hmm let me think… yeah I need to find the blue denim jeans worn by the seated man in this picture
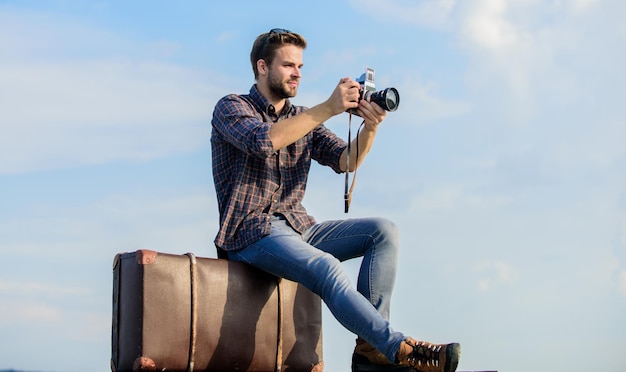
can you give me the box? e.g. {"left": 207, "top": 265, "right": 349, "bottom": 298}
{"left": 228, "top": 216, "right": 405, "bottom": 362}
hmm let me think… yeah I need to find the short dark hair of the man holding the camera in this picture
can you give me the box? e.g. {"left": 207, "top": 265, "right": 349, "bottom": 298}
{"left": 250, "top": 28, "right": 306, "bottom": 79}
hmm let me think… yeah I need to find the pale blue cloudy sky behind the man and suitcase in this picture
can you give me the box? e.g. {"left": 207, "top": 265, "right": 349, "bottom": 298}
{"left": 0, "top": 0, "right": 626, "bottom": 372}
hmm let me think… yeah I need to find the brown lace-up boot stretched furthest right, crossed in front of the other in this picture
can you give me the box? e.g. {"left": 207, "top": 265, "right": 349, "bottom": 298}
{"left": 396, "top": 338, "right": 461, "bottom": 372}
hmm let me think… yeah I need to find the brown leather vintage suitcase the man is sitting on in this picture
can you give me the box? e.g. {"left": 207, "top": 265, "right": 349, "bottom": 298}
{"left": 111, "top": 250, "right": 323, "bottom": 372}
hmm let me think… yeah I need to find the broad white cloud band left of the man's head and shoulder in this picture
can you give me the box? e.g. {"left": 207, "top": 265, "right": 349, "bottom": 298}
{"left": 0, "top": 61, "right": 210, "bottom": 173}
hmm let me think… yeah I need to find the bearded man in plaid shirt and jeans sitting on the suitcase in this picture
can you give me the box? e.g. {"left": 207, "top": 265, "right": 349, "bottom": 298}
{"left": 211, "top": 29, "right": 460, "bottom": 372}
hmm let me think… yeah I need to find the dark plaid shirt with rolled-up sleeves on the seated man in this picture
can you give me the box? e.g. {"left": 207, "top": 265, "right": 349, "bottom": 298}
{"left": 211, "top": 85, "right": 347, "bottom": 250}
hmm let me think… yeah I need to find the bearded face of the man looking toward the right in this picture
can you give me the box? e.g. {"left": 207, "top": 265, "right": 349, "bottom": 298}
{"left": 267, "top": 45, "right": 302, "bottom": 99}
